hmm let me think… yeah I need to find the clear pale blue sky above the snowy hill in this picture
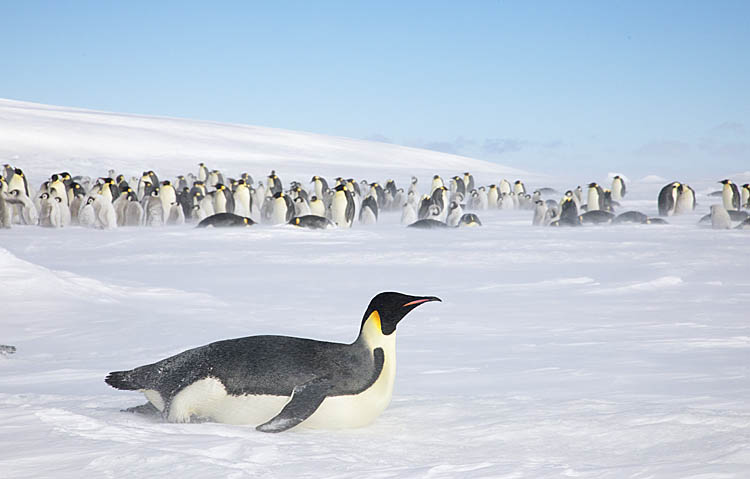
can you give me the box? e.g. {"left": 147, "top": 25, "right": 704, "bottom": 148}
{"left": 0, "top": 1, "right": 750, "bottom": 174}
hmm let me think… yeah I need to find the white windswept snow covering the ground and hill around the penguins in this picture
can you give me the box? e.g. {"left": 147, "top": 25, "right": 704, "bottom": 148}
{"left": 0, "top": 101, "right": 750, "bottom": 479}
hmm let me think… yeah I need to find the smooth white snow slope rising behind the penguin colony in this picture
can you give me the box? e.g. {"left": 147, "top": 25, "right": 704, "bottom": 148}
{"left": 0, "top": 99, "right": 522, "bottom": 181}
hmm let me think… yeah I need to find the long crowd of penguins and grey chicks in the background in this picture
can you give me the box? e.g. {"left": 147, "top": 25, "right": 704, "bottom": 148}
{"left": 0, "top": 163, "right": 750, "bottom": 229}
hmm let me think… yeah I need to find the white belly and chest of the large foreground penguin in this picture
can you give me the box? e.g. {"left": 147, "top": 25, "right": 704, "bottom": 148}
{"left": 155, "top": 356, "right": 396, "bottom": 429}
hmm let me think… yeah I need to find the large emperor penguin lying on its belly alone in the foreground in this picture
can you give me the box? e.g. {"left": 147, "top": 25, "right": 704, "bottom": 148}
{"left": 105, "top": 292, "right": 440, "bottom": 432}
